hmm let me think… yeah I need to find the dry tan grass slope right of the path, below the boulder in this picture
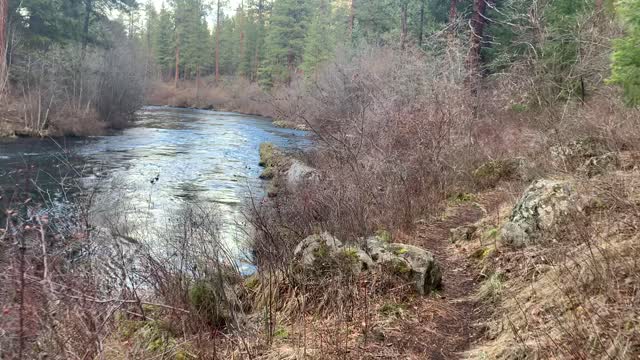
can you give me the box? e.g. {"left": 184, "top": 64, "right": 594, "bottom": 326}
{"left": 467, "top": 172, "right": 640, "bottom": 359}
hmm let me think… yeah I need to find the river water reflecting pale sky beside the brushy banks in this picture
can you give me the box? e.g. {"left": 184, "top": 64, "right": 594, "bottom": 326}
{"left": 0, "top": 107, "right": 308, "bottom": 266}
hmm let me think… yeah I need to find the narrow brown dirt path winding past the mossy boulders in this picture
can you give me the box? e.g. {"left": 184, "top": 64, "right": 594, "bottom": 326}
{"left": 372, "top": 204, "right": 484, "bottom": 360}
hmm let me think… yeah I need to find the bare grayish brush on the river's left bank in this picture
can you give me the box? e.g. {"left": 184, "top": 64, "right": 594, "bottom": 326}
{"left": 0, "top": 40, "right": 144, "bottom": 136}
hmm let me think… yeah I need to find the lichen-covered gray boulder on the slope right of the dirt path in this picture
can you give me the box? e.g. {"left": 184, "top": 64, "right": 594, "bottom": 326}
{"left": 501, "top": 180, "right": 580, "bottom": 247}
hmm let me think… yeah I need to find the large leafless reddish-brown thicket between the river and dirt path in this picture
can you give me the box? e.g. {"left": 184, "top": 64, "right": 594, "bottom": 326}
{"left": 250, "top": 48, "right": 473, "bottom": 261}
